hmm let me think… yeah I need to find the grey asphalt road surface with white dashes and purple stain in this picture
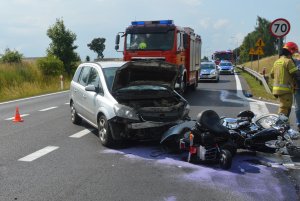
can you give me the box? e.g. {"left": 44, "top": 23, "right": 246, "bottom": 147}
{"left": 0, "top": 75, "right": 299, "bottom": 201}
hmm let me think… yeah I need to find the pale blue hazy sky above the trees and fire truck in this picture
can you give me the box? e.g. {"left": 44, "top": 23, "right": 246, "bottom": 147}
{"left": 0, "top": 0, "right": 300, "bottom": 60}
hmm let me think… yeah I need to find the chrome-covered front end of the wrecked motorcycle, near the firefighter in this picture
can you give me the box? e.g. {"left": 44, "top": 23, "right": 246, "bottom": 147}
{"left": 221, "top": 110, "right": 300, "bottom": 157}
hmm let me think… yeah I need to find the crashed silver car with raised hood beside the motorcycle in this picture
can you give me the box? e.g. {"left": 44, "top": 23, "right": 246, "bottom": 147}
{"left": 70, "top": 61, "right": 190, "bottom": 147}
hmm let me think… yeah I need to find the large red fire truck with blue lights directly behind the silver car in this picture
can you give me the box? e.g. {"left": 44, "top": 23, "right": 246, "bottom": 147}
{"left": 115, "top": 20, "right": 202, "bottom": 93}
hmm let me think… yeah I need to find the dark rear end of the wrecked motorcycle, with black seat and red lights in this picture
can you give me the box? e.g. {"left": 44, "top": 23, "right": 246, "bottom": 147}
{"left": 161, "top": 110, "right": 236, "bottom": 169}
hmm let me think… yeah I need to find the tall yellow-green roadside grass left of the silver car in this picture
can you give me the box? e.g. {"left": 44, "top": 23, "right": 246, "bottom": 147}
{"left": 0, "top": 62, "right": 70, "bottom": 102}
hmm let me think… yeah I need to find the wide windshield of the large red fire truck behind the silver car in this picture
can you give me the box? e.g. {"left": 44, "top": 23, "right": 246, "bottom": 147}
{"left": 126, "top": 31, "right": 174, "bottom": 50}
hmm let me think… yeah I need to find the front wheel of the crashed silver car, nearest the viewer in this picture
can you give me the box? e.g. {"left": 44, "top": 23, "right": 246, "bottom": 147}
{"left": 98, "top": 115, "right": 115, "bottom": 147}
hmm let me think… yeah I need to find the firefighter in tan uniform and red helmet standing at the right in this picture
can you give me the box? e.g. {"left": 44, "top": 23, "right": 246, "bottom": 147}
{"left": 270, "top": 42, "right": 298, "bottom": 117}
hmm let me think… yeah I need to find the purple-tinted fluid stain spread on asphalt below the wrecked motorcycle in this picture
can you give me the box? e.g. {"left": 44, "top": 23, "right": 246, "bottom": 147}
{"left": 101, "top": 146, "right": 298, "bottom": 200}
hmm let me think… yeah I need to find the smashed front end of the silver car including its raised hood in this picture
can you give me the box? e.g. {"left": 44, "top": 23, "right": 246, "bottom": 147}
{"left": 111, "top": 61, "right": 189, "bottom": 140}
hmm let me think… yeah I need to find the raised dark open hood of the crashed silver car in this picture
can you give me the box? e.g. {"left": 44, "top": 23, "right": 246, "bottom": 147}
{"left": 112, "top": 61, "right": 179, "bottom": 91}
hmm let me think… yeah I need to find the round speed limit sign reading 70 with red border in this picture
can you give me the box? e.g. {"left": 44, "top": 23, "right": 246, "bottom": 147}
{"left": 270, "top": 18, "right": 291, "bottom": 38}
